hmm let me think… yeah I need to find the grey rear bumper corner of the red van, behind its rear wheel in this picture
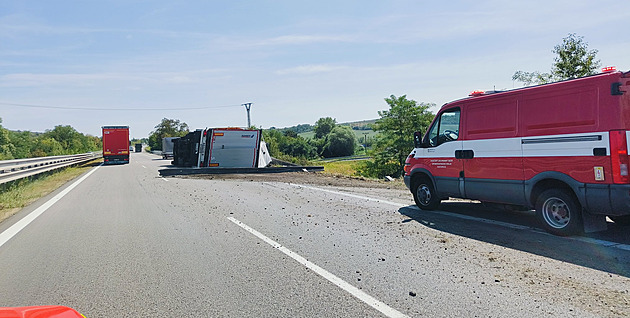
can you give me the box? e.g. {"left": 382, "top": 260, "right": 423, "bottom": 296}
{"left": 585, "top": 184, "right": 630, "bottom": 216}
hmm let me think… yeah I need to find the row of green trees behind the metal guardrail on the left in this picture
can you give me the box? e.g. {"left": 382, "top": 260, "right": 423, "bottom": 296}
{"left": 0, "top": 118, "right": 103, "bottom": 160}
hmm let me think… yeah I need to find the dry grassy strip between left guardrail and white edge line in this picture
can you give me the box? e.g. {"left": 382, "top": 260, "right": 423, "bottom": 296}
{"left": 0, "top": 159, "right": 101, "bottom": 222}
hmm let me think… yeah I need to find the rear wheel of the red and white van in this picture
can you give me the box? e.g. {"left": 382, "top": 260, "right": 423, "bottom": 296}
{"left": 536, "top": 189, "right": 584, "bottom": 236}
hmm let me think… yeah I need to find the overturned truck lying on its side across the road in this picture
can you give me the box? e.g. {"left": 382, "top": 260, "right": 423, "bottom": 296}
{"left": 172, "top": 128, "right": 271, "bottom": 168}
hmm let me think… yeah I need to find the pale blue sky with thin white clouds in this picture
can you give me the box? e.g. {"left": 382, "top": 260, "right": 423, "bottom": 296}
{"left": 0, "top": 0, "right": 630, "bottom": 138}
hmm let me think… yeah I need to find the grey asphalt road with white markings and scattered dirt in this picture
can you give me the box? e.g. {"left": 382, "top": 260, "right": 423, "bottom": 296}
{"left": 0, "top": 153, "right": 630, "bottom": 317}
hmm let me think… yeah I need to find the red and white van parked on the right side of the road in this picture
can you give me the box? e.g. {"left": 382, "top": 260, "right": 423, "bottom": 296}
{"left": 404, "top": 70, "right": 630, "bottom": 235}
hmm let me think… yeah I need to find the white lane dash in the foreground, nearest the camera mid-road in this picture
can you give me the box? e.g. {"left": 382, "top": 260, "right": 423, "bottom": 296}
{"left": 228, "top": 217, "right": 409, "bottom": 317}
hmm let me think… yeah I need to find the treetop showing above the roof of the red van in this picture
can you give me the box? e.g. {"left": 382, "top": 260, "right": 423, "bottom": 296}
{"left": 512, "top": 33, "right": 600, "bottom": 85}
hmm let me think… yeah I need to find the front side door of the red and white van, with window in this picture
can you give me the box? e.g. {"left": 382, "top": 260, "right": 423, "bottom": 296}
{"left": 421, "top": 107, "right": 463, "bottom": 197}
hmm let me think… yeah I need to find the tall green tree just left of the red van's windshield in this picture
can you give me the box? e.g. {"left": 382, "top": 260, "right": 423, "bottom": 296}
{"left": 360, "top": 95, "right": 435, "bottom": 178}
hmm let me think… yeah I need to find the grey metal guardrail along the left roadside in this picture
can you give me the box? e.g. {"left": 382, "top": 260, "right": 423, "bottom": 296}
{"left": 0, "top": 152, "right": 102, "bottom": 184}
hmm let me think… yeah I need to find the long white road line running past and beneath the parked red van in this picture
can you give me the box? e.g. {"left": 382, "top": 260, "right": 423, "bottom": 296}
{"left": 278, "top": 183, "right": 630, "bottom": 251}
